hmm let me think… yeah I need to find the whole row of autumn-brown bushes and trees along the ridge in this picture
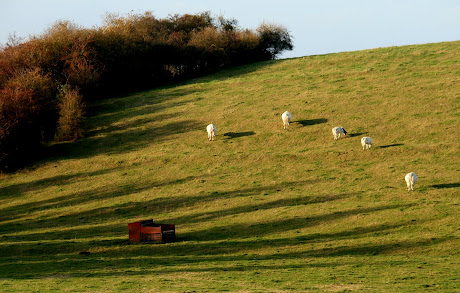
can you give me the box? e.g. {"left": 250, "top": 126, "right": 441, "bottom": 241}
{"left": 0, "top": 12, "right": 292, "bottom": 170}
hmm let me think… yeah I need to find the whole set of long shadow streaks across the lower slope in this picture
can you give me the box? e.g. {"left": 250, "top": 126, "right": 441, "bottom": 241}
{"left": 0, "top": 169, "right": 445, "bottom": 279}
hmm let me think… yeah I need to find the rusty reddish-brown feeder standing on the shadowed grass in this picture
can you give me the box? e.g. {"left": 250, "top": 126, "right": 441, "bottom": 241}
{"left": 128, "top": 220, "right": 176, "bottom": 242}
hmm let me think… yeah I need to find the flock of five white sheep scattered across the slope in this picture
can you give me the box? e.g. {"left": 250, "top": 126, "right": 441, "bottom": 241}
{"left": 206, "top": 111, "right": 418, "bottom": 191}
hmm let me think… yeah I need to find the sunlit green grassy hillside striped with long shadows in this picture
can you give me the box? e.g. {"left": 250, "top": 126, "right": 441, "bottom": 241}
{"left": 0, "top": 42, "right": 460, "bottom": 292}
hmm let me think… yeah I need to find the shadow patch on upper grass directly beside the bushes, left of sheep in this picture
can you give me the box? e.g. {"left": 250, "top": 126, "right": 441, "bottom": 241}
{"left": 34, "top": 88, "right": 201, "bottom": 164}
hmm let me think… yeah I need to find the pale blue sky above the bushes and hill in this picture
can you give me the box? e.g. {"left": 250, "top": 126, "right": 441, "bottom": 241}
{"left": 0, "top": 0, "right": 460, "bottom": 58}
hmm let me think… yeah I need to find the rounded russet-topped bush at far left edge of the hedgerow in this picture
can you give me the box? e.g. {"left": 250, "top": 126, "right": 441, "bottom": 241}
{"left": 0, "top": 68, "right": 57, "bottom": 167}
